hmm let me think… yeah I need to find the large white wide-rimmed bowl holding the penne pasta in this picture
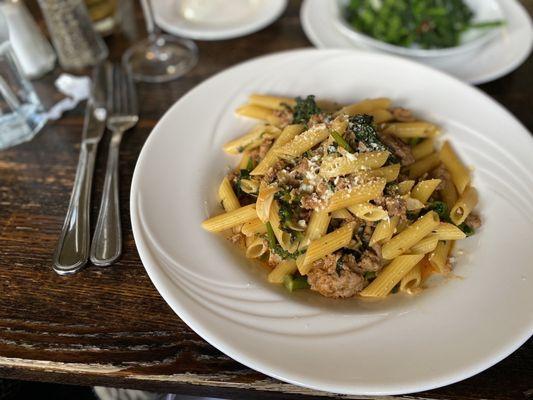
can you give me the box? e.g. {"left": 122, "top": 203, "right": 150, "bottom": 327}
{"left": 131, "top": 49, "right": 533, "bottom": 395}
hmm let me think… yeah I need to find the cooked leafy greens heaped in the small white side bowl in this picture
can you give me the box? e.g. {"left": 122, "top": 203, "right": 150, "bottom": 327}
{"left": 345, "top": 0, "right": 494, "bottom": 49}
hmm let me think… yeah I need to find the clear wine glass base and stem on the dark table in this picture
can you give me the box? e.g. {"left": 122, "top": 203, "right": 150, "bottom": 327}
{"left": 122, "top": 0, "right": 198, "bottom": 82}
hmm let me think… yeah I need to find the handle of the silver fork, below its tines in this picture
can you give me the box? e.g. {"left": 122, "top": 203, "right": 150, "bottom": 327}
{"left": 91, "top": 130, "right": 123, "bottom": 266}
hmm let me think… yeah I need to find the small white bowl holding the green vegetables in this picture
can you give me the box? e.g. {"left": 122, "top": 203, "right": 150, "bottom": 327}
{"left": 331, "top": 0, "right": 505, "bottom": 58}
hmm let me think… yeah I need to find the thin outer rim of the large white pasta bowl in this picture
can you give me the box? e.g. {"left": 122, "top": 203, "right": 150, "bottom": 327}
{"left": 130, "top": 48, "right": 533, "bottom": 396}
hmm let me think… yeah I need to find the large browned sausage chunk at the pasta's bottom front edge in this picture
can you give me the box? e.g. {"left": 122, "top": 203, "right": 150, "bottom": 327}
{"left": 307, "top": 254, "right": 365, "bottom": 298}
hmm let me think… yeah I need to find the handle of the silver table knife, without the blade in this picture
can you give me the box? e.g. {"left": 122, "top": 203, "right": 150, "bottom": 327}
{"left": 53, "top": 142, "right": 97, "bottom": 275}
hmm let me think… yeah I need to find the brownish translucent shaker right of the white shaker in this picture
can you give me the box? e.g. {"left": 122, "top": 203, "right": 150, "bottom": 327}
{"left": 39, "top": 0, "right": 108, "bottom": 70}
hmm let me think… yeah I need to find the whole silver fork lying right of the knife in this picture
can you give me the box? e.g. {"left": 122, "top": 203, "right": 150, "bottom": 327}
{"left": 90, "top": 65, "right": 139, "bottom": 266}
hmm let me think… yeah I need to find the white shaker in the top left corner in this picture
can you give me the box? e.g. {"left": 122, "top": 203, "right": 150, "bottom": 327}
{"left": 0, "top": 0, "right": 56, "bottom": 78}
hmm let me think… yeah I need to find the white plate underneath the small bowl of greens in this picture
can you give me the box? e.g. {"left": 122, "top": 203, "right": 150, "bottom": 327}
{"left": 300, "top": 0, "right": 533, "bottom": 85}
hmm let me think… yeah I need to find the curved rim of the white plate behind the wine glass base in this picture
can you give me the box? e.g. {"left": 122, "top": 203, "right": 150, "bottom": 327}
{"left": 154, "top": 0, "right": 288, "bottom": 41}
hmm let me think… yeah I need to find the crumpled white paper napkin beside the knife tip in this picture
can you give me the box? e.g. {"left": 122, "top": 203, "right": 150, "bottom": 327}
{"left": 45, "top": 74, "right": 91, "bottom": 120}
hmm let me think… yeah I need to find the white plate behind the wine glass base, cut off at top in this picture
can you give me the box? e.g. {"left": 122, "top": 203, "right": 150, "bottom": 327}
{"left": 152, "top": 0, "right": 287, "bottom": 40}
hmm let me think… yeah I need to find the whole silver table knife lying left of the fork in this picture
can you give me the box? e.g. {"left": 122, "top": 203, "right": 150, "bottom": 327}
{"left": 53, "top": 63, "right": 110, "bottom": 275}
